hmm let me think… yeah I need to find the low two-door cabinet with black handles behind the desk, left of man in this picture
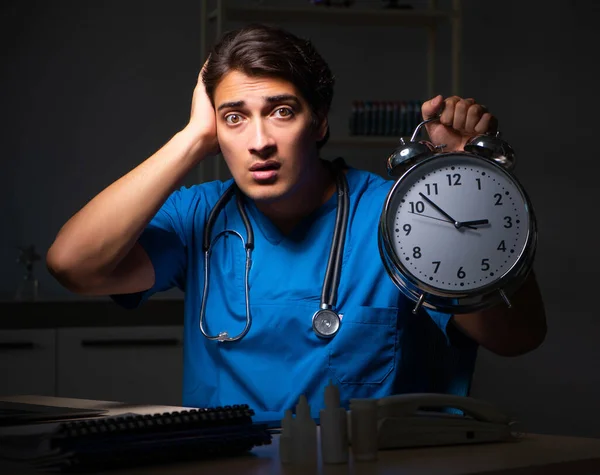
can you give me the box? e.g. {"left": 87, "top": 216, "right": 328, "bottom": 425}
{"left": 0, "top": 325, "right": 183, "bottom": 406}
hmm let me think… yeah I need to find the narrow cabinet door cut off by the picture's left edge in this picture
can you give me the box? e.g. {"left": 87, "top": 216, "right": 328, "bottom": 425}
{"left": 0, "top": 329, "right": 56, "bottom": 396}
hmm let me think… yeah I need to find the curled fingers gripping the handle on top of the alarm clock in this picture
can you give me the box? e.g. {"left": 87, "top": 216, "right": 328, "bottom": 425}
{"left": 440, "top": 96, "right": 498, "bottom": 135}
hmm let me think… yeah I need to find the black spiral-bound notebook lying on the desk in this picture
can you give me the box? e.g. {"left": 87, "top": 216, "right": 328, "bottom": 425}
{"left": 0, "top": 404, "right": 272, "bottom": 472}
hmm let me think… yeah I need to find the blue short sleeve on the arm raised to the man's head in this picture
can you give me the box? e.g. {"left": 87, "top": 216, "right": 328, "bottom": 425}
{"left": 111, "top": 190, "right": 191, "bottom": 308}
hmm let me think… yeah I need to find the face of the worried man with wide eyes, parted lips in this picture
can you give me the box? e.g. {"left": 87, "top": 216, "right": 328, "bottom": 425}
{"left": 214, "top": 71, "right": 326, "bottom": 203}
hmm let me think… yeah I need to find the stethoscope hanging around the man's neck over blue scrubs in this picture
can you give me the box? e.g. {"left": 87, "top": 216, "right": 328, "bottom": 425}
{"left": 199, "top": 162, "right": 349, "bottom": 342}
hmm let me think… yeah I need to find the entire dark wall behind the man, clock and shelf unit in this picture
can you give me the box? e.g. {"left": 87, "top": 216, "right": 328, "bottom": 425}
{"left": 0, "top": 0, "right": 600, "bottom": 437}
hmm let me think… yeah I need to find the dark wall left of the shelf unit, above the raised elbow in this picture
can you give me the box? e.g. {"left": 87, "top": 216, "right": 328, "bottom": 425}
{"left": 0, "top": 0, "right": 201, "bottom": 298}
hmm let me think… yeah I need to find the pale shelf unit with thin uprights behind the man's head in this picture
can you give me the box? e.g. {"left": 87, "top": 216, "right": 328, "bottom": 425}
{"left": 200, "top": 0, "right": 462, "bottom": 177}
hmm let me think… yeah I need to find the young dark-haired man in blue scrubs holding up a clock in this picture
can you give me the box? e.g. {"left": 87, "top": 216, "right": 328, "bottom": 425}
{"left": 47, "top": 26, "right": 546, "bottom": 419}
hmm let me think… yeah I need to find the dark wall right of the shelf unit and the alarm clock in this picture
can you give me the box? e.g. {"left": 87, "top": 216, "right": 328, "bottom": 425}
{"left": 463, "top": 0, "right": 600, "bottom": 437}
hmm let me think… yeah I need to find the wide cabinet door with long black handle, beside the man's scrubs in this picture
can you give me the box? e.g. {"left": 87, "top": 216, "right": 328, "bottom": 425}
{"left": 57, "top": 326, "right": 183, "bottom": 406}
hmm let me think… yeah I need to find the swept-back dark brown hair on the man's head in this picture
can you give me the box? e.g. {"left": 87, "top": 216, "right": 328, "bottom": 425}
{"left": 202, "top": 24, "right": 335, "bottom": 148}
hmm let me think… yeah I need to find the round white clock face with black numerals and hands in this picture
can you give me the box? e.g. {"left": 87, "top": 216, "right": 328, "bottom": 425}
{"left": 387, "top": 154, "right": 530, "bottom": 293}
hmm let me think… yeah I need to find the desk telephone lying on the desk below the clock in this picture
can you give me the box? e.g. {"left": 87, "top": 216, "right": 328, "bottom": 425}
{"left": 377, "top": 393, "right": 522, "bottom": 449}
